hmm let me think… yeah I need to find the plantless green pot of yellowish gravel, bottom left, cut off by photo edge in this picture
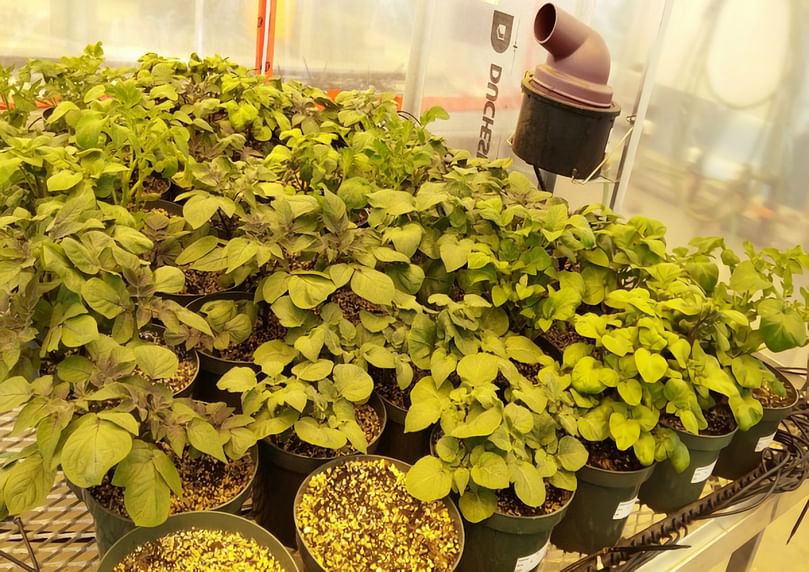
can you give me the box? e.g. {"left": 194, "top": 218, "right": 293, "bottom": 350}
{"left": 98, "top": 511, "right": 298, "bottom": 572}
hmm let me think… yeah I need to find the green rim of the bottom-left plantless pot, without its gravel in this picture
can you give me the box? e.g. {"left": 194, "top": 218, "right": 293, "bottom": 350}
{"left": 98, "top": 511, "right": 298, "bottom": 572}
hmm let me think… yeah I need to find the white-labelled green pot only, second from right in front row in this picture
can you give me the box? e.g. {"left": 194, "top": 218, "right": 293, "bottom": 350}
{"left": 639, "top": 429, "right": 736, "bottom": 512}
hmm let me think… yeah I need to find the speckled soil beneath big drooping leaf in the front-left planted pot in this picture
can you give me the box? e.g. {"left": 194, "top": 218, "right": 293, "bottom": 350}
{"left": 90, "top": 443, "right": 255, "bottom": 518}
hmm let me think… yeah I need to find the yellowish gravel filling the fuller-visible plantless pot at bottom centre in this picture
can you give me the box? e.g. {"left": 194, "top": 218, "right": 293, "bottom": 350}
{"left": 296, "top": 459, "right": 461, "bottom": 572}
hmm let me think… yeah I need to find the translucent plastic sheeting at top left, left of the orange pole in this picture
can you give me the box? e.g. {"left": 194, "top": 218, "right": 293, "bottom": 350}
{"left": 0, "top": 0, "right": 257, "bottom": 67}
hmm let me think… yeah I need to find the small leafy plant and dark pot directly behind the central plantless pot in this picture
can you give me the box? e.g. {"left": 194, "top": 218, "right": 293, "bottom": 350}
{"left": 218, "top": 358, "right": 386, "bottom": 544}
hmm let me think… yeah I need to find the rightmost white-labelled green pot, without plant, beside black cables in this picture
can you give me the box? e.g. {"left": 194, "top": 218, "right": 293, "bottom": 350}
{"left": 714, "top": 364, "right": 798, "bottom": 479}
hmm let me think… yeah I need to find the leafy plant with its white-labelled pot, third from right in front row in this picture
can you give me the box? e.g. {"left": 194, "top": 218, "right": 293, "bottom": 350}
{"left": 538, "top": 332, "right": 688, "bottom": 553}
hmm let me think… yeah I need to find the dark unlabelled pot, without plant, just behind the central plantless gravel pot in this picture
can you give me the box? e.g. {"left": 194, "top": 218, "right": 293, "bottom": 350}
{"left": 253, "top": 394, "right": 387, "bottom": 546}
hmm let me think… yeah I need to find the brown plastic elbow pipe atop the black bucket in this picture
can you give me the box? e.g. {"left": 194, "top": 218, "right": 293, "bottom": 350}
{"left": 534, "top": 3, "right": 612, "bottom": 107}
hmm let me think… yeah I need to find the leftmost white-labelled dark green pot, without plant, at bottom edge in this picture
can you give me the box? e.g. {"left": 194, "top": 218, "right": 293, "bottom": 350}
{"left": 458, "top": 494, "right": 575, "bottom": 572}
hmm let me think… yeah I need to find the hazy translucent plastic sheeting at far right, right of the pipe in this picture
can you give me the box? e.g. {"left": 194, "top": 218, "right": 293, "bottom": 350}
{"left": 625, "top": 0, "right": 809, "bottom": 252}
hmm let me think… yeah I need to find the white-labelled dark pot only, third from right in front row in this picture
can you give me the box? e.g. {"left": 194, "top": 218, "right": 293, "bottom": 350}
{"left": 551, "top": 465, "right": 654, "bottom": 554}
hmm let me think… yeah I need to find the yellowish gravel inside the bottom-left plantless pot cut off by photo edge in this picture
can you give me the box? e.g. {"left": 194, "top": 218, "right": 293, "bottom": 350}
{"left": 114, "top": 528, "right": 284, "bottom": 572}
